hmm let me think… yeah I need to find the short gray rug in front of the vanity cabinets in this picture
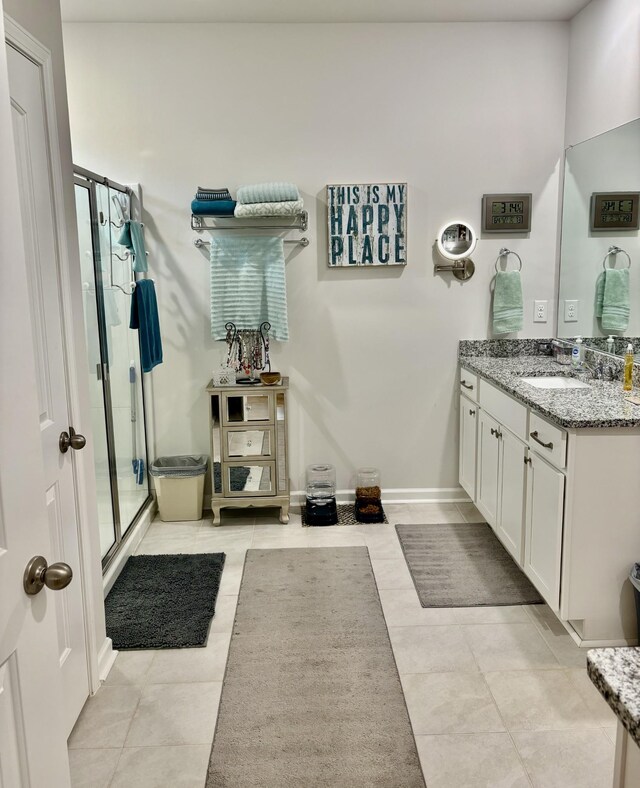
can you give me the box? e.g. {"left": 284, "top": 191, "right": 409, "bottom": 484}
{"left": 396, "top": 523, "right": 543, "bottom": 607}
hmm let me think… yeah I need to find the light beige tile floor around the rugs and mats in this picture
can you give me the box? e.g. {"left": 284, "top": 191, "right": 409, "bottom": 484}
{"left": 69, "top": 504, "right": 615, "bottom": 788}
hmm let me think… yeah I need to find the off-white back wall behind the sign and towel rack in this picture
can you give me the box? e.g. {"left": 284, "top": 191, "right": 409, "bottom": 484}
{"left": 64, "top": 23, "right": 568, "bottom": 489}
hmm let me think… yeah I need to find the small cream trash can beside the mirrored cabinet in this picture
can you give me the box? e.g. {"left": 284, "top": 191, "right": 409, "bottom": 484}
{"left": 149, "top": 454, "right": 208, "bottom": 522}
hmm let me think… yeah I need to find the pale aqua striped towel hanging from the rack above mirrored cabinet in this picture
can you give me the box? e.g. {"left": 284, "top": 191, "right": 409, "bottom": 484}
{"left": 211, "top": 236, "right": 289, "bottom": 341}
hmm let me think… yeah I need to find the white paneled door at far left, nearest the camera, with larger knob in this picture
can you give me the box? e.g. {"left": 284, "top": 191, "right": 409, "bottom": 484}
{"left": 0, "top": 14, "right": 73, "bottom": 788}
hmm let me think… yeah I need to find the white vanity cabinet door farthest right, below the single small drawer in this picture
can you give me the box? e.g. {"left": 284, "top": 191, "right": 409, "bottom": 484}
{"left": 524, "top": 452, "right": 564, "bottom": 611}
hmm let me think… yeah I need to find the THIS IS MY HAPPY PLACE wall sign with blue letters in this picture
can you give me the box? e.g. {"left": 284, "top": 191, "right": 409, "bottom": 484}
{"left": 327, "top": 183, "right": 407, "bottom": 268}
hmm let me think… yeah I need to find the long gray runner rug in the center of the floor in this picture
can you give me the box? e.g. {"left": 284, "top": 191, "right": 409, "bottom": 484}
{"left": 206, "top": 547, "right": 425, "bottom": 788}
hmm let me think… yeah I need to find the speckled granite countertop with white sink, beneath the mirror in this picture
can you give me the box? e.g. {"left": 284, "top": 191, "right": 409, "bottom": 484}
{"left": 459, "top": 355, "right": 640, "bottom": 429}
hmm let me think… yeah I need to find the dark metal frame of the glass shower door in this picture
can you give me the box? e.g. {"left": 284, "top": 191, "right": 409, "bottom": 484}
{"left": 73, "top": 164, "right": 153, "bottom": 574}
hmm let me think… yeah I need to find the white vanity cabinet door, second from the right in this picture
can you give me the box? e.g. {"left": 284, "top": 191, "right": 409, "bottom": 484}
{"left": 497, "top": 428, "right": 527, "bottom": 566}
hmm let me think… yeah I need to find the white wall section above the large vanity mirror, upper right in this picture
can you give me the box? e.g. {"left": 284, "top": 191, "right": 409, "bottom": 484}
{"left": 565, "top": 0, "right": 640, "bottom": 145}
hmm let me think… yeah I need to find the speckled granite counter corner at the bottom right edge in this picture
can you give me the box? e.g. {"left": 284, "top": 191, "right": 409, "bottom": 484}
{"left": 587, "top": 647, "right": 640, "bottom": 745}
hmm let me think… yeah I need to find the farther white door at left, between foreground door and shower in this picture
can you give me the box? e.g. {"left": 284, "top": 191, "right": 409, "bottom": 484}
{"left": 7, "top": 37, "right": 89, "bottom": 734}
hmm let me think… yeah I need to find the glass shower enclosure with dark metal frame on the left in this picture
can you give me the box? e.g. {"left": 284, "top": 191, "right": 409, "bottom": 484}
{"left": 74, "top": 167, "right": 150, "bottom": 568}
